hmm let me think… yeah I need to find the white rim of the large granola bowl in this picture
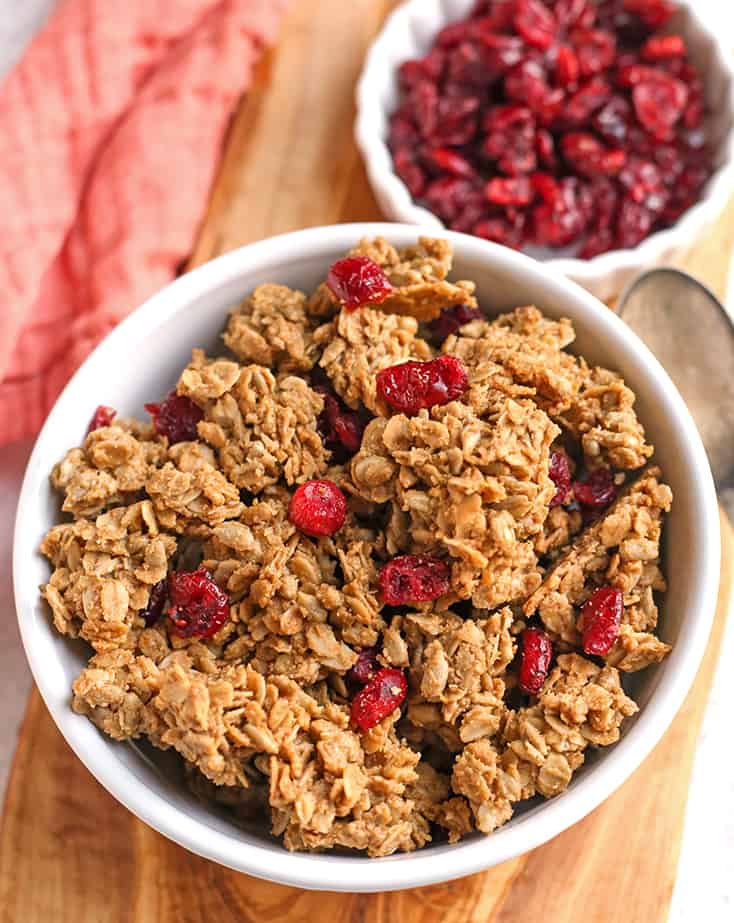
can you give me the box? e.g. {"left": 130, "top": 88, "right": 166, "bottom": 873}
{"left": 13, "top": 223, "right": 720, "bottom": 892}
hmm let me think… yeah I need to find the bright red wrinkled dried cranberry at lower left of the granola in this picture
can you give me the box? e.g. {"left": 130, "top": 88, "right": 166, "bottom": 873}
{"left": 167, "top": 568, "right": 229, "bottom": 638}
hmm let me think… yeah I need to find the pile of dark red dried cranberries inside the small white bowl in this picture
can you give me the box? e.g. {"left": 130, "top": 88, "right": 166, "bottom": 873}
{"left": 389, "top": 0, "right": 713, "bottom": 259}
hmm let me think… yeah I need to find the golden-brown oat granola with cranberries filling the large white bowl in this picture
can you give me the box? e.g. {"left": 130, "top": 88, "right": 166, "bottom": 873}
{"left": 41, "top": 239, "right": 672, "bottom": 856}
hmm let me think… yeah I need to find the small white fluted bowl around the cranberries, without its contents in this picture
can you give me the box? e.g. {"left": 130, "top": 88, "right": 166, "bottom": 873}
{"left": 355, "top": 0, "right": 734, "bottom": 301}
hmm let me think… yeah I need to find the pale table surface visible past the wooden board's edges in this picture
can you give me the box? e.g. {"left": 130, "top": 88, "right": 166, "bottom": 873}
{"left": 0, "top": 0, "right": 734, "bottom": 923}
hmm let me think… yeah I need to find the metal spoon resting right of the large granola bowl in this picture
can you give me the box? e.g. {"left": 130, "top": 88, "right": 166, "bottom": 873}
{"left": 616, "top": 269, "right": 734, "bottom": 516}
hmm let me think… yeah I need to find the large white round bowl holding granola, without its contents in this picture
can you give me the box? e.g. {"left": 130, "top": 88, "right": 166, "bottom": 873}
{"left": 14, "top": 224, "right": 719, "bottom": 891}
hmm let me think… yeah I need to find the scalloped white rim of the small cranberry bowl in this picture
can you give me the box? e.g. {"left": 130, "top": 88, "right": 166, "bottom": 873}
{"left": 354, "top": 0, "right": 734, "bottom": 286}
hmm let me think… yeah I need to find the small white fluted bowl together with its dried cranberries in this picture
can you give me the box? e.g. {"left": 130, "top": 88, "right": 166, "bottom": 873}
{"left": 356, "top": 0, "right": 734, "bottom": 299}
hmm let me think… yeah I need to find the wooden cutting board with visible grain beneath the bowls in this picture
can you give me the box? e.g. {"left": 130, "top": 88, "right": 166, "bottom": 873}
{"left": 0, "top": 0, "right": 734, "bottom": 923}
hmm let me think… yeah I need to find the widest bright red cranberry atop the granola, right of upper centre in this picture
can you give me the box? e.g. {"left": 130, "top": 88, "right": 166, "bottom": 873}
{"left": 377, "top": 356, "right": 469, "bottom": 414}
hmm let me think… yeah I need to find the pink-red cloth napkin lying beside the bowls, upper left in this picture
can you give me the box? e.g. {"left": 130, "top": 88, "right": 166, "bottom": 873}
{"left": 0, "top": 0, "right": 287, "bottom": 445}
